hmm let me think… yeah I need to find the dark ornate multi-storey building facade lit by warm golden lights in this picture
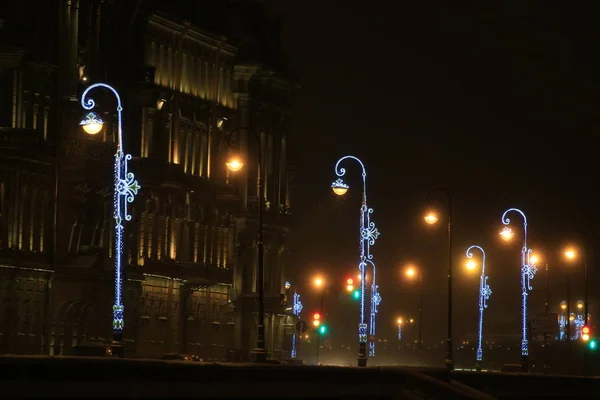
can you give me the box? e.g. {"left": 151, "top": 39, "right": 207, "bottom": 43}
{"left": 0, "top": 0, "right": 295, "bottom": 361}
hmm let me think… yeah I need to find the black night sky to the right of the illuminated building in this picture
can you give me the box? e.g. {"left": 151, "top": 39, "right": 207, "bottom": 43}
{"left": 270, "top": 0, "right": 599, "bottom": 343}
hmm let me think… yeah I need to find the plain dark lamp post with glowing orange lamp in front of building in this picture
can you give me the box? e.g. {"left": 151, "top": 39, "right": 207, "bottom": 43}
{"left": 226, "top": 126, "right": 267, "bottom": 362}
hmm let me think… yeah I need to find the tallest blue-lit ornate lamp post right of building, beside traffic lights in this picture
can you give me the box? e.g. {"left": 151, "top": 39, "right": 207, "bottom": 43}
{"left": 331, "top": 156, "right": 381, "bottom": 367}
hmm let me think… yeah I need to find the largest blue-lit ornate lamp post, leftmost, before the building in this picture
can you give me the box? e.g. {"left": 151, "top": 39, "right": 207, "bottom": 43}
{"left": 80, "top": 83, "right": 140, "bottom": 350}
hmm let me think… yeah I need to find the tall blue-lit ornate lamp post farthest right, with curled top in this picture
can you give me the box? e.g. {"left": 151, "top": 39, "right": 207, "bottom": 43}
{"left": 500, "top": 208, "right": 537, "bottom": 372}
